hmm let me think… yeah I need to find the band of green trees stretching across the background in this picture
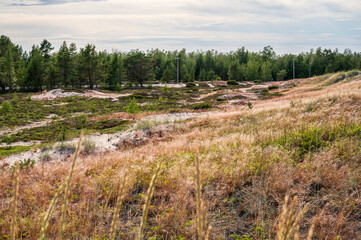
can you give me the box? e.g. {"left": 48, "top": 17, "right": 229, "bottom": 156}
{"left": 0, "top": 35, "right": 361, "bottom": 92}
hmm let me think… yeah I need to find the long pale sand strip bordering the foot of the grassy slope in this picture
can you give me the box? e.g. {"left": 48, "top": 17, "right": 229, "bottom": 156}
{"left": 1, "top": 112, "right": 208, "bottom": 166}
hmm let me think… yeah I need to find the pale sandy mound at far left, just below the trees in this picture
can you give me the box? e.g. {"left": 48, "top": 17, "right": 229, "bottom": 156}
{"left": 31, "top": 89, "right": 132, "bottom": 101}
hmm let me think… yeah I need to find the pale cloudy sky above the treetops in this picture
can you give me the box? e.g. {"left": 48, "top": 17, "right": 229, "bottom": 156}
{"left": 0, "top": 0, "right": 361, "bottom": 54}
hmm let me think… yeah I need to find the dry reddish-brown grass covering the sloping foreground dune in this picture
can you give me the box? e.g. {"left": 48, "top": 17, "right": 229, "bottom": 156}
{"left": 0, "top": 73, "right": 361, "bottom": 240}
